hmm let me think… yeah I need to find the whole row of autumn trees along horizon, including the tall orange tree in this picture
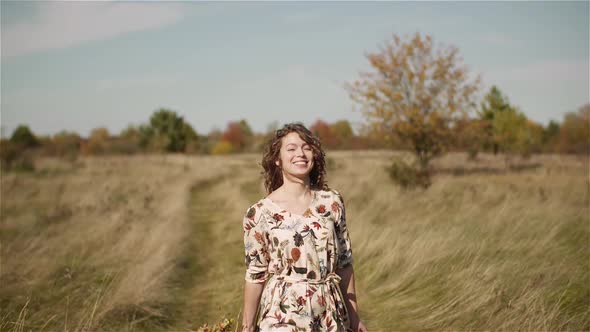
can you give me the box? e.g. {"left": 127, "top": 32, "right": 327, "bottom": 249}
{"left": 0, "top": 33, "right": 590, "bottom": 174}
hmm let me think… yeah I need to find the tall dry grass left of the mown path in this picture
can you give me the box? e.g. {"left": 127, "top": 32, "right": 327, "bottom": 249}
{"left": 0, "top": 156, "right": 237, "bottom": 331}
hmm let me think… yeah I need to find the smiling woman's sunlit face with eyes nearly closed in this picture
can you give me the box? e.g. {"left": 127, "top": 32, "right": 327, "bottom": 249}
{"left": 275, "top": 132, "right": 313, "bottom": 178}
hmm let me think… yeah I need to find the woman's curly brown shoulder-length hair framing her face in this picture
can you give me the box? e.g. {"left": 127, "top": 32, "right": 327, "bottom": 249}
{"left": 261, "top": 122, "right": 329, "bottom": 194}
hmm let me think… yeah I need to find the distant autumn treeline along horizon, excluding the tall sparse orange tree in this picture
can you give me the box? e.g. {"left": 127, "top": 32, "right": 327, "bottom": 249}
{"left": 0, "top": 93, "right": 590, "bottom": 170}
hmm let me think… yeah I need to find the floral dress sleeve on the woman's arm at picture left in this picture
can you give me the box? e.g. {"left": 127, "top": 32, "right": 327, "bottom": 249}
{"left": 242, "top": 205, "right": 270, "bottom": 283}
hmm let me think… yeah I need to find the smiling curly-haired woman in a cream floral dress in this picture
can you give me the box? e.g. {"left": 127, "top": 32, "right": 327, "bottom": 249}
{"left": 242, "top": 123, "right": 367, "bottom": 332}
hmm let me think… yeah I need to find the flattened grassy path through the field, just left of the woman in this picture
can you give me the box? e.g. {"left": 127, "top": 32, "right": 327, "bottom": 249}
{"left": 162, "top": 162, "right": 262, "bottom": 331}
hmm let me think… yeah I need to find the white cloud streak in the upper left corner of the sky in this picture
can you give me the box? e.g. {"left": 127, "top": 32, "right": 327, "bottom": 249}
{"left": 2, "top": 1, "right": 183, "bottom": 57}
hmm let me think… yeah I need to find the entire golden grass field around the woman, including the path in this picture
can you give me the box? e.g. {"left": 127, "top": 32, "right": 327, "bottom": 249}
{"left": 0, "top": 151, "right": 590, "bottom": 331}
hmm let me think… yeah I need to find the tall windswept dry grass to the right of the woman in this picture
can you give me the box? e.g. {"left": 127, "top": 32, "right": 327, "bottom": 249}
{"left": 331, "top": 153, "right": 590, "bottom": 331}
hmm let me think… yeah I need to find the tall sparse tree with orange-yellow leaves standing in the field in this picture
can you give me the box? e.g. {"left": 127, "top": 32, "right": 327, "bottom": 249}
{"left": 347, "top": 33, "right": 479, "bottom": 178}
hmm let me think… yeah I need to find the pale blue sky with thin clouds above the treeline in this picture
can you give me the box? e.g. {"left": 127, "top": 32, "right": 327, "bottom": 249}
{"left": 0, "top": 1, "right": 590, "bottom": 136}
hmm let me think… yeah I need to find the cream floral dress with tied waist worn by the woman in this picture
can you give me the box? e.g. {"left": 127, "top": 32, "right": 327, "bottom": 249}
{"left": 243, "top": 190, "right": 352, "bottom": 332}
